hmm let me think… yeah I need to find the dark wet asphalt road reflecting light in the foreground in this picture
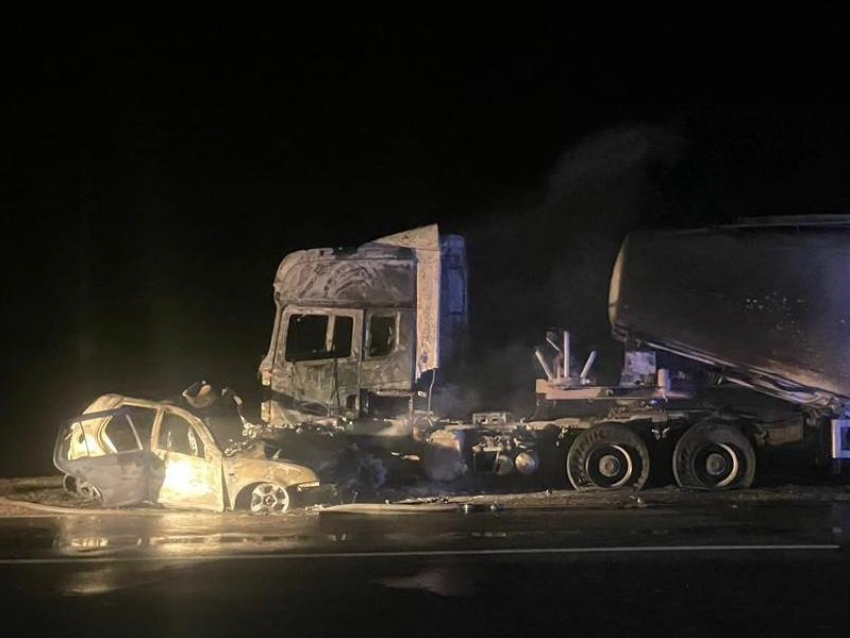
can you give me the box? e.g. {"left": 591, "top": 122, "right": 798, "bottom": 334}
{"left": 0, "top": 503, "right": 850, "bottom": 636}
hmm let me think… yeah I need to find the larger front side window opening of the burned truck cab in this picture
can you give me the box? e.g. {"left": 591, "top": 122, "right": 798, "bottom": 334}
{"left": 286, "top": 314, "right": 354, "bottom": 361}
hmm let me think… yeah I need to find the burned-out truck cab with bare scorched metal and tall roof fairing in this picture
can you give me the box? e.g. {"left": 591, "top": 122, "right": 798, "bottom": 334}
{"left": 260, "top": 225, "right": 467, "bottom": 435}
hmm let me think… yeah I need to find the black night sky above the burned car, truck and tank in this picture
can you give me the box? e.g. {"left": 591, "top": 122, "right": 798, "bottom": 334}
{"left": 0, "top": 12, "right": 850, "bottom": 476}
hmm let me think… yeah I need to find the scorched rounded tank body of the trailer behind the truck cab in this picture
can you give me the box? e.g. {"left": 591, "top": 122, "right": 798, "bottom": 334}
{"left": 609, "top": 223, "right": 850, "bottom": 405}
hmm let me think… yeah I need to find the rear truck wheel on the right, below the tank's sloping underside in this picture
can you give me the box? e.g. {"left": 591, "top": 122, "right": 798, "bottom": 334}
{"left": 673, "top": 421, "right": 756, "bottom": 490}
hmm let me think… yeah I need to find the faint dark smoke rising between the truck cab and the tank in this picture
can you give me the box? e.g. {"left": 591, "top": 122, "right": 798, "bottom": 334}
{"left": 454, "top": 124, "right": 685, "bottom": 414}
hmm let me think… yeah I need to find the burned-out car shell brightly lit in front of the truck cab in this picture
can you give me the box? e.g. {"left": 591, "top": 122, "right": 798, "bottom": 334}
{"left": 53, "top": 393, "right": 327, "bottom": 514}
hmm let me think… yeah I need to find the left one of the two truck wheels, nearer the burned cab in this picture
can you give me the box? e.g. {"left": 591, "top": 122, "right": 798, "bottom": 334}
{"left": 567, "top": 423, "right": 649, "bottom": 490}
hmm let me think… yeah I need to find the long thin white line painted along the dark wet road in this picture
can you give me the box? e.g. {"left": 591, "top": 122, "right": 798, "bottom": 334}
{"left": 0, "top": 545, "right": 841, "bottom": 565}
